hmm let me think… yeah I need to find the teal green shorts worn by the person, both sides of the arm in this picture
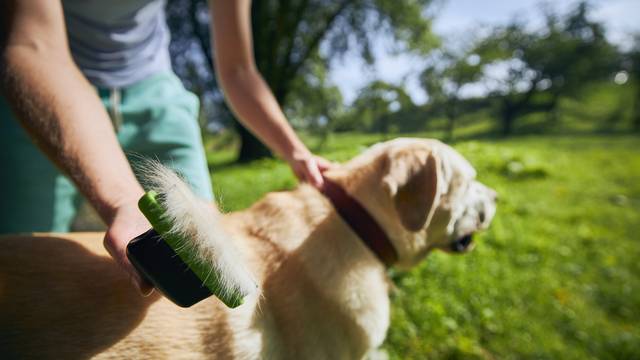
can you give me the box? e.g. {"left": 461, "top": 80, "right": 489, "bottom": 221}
{"left": 0, "top": 72, "right": 213, "bottom": 234}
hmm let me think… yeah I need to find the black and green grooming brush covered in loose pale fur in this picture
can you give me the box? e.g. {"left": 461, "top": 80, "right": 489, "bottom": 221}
{"left": 127, "top": 162, "right": 257, "bottom": 308}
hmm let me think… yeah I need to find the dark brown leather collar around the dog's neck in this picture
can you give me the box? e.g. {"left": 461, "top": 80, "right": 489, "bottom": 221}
{"left": 322, "top": 177, "right": 398, "bottom": 267}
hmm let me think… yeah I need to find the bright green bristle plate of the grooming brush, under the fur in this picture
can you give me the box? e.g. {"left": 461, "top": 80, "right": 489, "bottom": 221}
{"left": 138, "top": 190, "right": 244, "bottom": 308}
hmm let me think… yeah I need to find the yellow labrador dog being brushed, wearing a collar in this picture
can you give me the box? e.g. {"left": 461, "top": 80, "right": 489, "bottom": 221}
{"left": 0, "top": 139, "right": 496, "bottom": 359}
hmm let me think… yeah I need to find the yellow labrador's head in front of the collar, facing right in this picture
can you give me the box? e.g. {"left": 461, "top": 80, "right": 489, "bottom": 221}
{"left": 338, "top": 138, "right": 496, "bottom": 267}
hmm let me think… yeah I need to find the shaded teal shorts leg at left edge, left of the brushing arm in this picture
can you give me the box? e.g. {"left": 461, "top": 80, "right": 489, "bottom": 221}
{"left": 0, "top": 97, "right": 78, "bottom": 234}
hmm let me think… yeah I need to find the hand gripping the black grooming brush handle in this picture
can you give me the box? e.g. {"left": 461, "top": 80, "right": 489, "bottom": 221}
{"left": 104, "top": 202, "right": 153, "bottom": 296}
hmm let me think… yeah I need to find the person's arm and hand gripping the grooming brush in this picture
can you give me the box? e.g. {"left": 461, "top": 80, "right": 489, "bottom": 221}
{"left": 0, "top": 0, "right": 149, "bottom": 291}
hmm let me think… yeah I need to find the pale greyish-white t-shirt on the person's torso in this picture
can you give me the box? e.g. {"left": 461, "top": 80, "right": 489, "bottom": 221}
{"left": 62, "top": 0, "right": 171, "bottom": 88}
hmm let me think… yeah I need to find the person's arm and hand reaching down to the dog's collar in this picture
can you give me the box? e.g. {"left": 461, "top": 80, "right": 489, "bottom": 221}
{"left": 211, "top": 0, "right": 329, "bottom": 187}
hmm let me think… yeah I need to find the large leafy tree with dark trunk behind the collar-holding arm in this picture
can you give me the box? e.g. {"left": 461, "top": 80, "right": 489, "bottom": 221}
{"left": 168, "top": 0, "right": 436, "bottom": 161}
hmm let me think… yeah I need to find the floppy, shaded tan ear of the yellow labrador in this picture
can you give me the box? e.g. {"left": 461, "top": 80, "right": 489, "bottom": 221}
{"left": 383, "top": 150, "right": 440, "bottom": 232}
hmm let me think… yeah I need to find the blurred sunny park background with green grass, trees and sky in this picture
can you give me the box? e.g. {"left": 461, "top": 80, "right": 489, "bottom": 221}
{"left": 167, "top": 0, "right": 640, "bottom": 359}
